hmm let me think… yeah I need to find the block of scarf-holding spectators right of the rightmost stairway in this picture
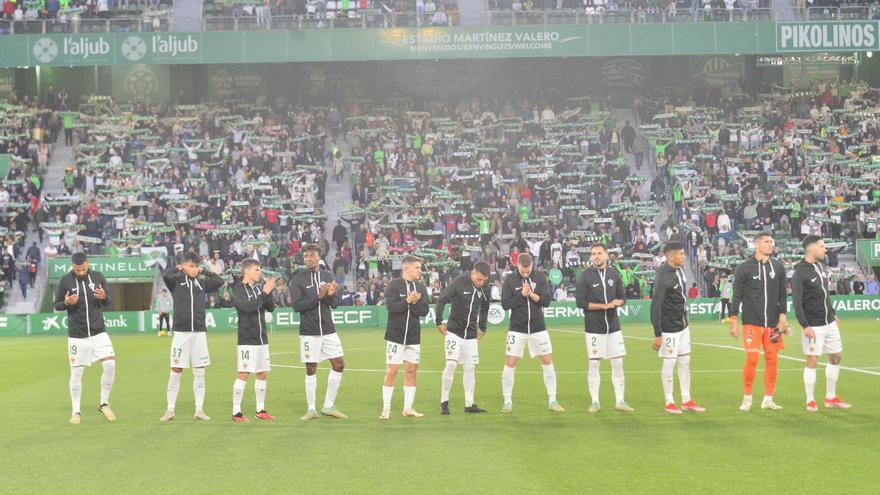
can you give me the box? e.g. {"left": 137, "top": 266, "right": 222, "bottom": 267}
{"left": 637, "top": 75, "right": 880, "bottom": 297}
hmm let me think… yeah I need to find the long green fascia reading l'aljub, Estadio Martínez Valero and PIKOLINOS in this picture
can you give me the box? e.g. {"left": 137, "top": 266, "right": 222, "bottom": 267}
{"left": 0, "top": 21, "right": 878, "bottom": 68}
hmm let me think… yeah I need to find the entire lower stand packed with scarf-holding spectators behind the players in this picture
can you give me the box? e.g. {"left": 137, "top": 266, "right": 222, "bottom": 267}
{"left": 4, "top": 73, "right": 880, "bottom": 314}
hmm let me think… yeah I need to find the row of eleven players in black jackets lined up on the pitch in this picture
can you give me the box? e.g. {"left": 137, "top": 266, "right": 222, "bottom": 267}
{"left": 55, "top": 233, "right": 851, "bottom": 424}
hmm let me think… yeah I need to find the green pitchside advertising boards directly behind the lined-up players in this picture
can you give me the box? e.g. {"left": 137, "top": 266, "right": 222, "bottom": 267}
{"left": 8, "top": 296, "right": 880, "bottom": 336}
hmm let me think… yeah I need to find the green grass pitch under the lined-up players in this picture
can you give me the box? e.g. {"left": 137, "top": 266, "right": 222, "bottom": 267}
{"left": 0, "top": 319, "right": 880, "bottom": 495}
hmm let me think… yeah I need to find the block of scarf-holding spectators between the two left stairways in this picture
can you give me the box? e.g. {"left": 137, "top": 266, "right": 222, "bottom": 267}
{"left": 38, "top": 93, "right": 335, "bottom": 304}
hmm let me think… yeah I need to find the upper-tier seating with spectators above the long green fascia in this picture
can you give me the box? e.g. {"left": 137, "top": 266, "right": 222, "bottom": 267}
{"left": 8, "top": 0, "right": 880, "bottom": 34}
